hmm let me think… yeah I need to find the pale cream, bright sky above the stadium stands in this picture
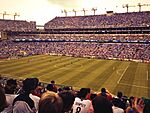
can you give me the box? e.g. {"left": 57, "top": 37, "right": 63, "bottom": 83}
{"left": 0, "top": 0, "right": 150, "bottom": 25}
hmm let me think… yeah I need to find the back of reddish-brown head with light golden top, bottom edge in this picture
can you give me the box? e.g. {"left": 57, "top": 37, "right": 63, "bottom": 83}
{"left": 38, "top": 91, "right": 63, "bottom": 113}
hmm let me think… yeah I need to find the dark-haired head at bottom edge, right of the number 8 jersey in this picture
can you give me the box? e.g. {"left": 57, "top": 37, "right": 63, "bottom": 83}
{"left": 92, "top": 96, "right": 113, "bottom": 113}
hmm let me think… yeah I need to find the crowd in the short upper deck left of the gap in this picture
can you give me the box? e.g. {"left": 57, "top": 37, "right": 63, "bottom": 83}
{"left": 0, "top": 19, "right": 36, "bottom": 32}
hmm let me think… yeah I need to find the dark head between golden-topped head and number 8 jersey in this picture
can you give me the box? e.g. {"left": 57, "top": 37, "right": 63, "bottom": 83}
{"left": 59, "top": 92, "right": 75, "bottom": 113}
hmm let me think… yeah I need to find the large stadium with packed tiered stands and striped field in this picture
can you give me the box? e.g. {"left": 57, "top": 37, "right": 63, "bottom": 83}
{"left": 0, "top": 1, "right": 150, "bottom": 112}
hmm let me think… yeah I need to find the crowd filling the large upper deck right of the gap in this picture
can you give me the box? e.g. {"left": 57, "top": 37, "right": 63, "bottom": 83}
{"left": 44, "top": 11, "right": 150, "bottom": 29}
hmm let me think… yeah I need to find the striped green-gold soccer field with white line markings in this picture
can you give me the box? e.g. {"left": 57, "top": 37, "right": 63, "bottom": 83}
{"left": 0, "top": 55, "right": 150, "bottom": 98}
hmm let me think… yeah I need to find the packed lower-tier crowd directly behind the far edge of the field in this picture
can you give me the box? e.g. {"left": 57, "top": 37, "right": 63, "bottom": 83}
{"left": 0, "top": 41, "right": 150, "bottom": 61}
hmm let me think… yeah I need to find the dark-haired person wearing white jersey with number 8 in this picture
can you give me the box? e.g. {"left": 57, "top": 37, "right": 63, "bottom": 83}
{"left": 72, "top": 88, "right": 94, "bottom": 113}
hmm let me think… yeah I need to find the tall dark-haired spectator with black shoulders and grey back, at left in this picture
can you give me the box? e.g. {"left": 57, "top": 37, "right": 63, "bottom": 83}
{"left": 13, "top": 78, "right": 36, "bottom": 113}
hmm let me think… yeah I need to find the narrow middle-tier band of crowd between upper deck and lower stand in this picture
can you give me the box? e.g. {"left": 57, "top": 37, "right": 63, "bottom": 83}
{"left": 11, "top": 34, "right": 150, "bottom": 42}
